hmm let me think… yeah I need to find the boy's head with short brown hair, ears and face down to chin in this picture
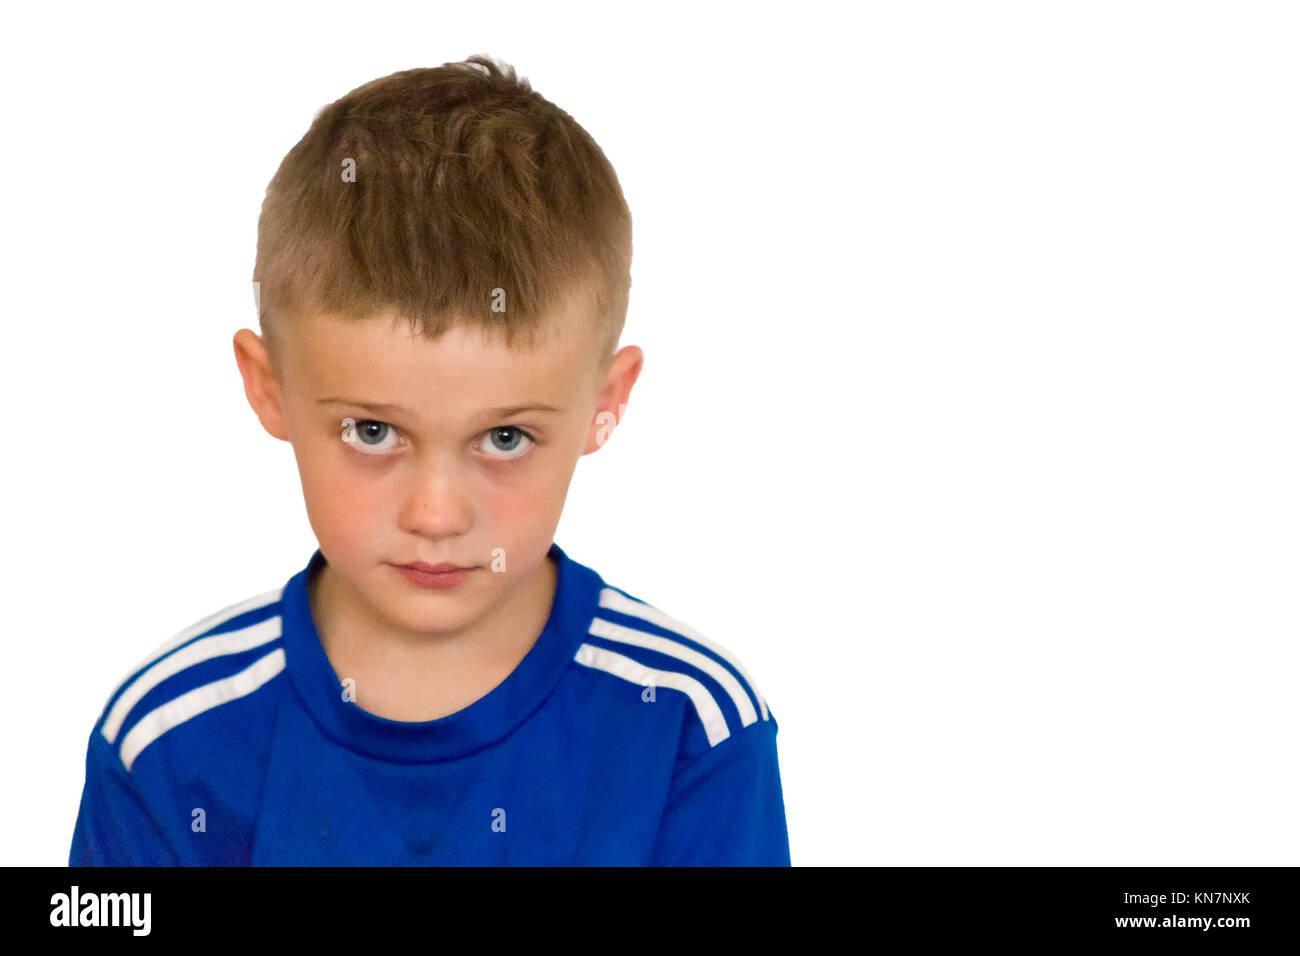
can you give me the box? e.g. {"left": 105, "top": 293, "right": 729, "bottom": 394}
{"left": 234, "top": 57, "right": 642, "bottom": 642}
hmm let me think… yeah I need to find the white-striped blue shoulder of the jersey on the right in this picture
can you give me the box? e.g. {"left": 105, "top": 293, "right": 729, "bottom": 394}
{"left": 575, "top": 581, "right": 776, "bottom": 750}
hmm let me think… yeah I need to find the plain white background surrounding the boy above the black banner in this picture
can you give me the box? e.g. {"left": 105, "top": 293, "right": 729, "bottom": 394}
{"left": 0, "top": 0, "right": 1300, "bottom": 865}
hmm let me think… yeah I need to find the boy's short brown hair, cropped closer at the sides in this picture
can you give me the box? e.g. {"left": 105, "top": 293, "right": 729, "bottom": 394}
{"left": 252, "top": 56, "right": 632, "bottom": 369}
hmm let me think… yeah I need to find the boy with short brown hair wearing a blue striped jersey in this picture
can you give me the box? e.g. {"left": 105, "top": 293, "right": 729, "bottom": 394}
{"left": 70, "top": 57, "right": 789, "bottom": 866}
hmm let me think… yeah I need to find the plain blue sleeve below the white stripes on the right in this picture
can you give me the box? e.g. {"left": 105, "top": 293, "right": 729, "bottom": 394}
{"left": 650, "top": 719, "right": 790, "bottom": 866}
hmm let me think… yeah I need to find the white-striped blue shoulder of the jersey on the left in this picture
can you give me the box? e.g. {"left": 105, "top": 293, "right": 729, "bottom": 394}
{"left": 94, "top": 585, "right": 285, "bottom": 770}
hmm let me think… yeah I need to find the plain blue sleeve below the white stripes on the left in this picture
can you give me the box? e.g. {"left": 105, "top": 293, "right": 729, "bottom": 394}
{"left": 68, "top": 726, "right": 179, "bottom": 866}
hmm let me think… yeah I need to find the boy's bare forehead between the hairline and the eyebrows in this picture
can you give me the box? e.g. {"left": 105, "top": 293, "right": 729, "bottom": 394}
{"left": 285, "top": 297, "right": 594, "bottom": 416}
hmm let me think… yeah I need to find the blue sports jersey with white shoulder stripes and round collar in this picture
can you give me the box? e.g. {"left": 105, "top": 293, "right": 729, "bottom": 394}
{"left": 69, "top": 544, "right": 790, "bottom": 866}
